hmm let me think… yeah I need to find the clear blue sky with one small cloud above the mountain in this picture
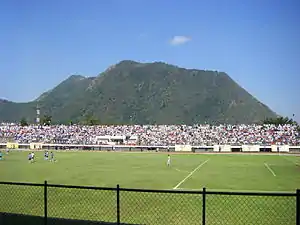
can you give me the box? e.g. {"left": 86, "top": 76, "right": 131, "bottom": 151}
{"left": 0, "top": 0, "right": 300, "bottom": 121}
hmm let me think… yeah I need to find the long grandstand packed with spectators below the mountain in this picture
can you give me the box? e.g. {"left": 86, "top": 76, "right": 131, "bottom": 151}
{"left": 0, "top": 124, "right": 300, "bottom": 146}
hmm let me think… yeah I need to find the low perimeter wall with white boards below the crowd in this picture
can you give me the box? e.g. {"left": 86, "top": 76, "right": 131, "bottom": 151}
{"left": 0, "top": 143, "right": 300, "bottom": 153}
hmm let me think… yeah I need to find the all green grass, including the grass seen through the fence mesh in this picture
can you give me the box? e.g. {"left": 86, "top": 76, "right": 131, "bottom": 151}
{"left": 0, "top": 151, "right": 300, "bottom": 224}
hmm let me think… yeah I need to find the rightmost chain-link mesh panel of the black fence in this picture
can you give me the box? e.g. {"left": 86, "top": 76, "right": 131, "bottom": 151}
{"left": 206, "top": 193, "right": 296, "bottom": 225}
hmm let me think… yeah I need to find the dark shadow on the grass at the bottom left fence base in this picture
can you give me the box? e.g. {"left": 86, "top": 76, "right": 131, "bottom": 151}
{"left": 0, "top": 213, "right": 141, "bottom": 225}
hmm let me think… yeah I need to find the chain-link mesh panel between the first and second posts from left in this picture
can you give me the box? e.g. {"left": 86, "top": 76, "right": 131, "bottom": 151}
{"left": 47, "top": 186, "right": 117, "bottom": 225}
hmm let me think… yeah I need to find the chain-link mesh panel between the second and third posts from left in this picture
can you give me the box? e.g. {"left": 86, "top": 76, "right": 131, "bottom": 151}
{"left": 120, "top": 189, "right": 202, "bottom": 225}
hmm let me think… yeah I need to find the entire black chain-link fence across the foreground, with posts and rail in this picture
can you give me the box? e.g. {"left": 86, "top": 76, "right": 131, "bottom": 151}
{"left": 0, "top": 182, "right": 300, "bottom": 225}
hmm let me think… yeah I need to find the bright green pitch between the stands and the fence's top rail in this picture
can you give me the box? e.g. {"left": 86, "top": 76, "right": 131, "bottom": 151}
{"left": 0, "top": 151, "right": 300, "bottom": 192}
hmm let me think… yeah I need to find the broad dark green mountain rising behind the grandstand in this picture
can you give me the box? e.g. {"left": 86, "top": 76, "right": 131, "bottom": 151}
{"left": 0, "top": 60, "right": 276, "bottom": 124}
